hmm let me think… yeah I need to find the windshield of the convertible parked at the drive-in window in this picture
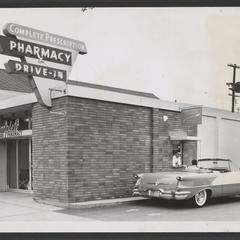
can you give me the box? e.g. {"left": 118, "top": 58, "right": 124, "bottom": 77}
{"left": 198, "top": 159, "right": 231, "bottom": 171}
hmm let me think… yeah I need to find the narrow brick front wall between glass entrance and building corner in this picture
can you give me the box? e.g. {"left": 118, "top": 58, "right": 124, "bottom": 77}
{"left": 32, "top": 97, "right": 68, "bottom": 202}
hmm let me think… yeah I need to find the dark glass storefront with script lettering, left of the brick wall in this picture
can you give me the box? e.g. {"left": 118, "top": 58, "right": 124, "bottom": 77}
{"left": 0, "top": 111, "right": 32, "bottom": 190}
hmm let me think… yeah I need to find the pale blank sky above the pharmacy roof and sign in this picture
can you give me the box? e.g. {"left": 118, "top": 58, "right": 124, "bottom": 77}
{"left": 0, "top": 7, "right": 240, "bottom": 111}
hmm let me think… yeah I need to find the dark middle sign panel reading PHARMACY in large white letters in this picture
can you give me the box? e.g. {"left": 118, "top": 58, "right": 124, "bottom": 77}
{"left": 0, "top": 36, "right": 72, "bottom": 66}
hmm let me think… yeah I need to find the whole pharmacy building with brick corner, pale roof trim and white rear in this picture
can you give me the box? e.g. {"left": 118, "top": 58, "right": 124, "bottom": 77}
{"left": 0, "top": 70, "right": 240, "bottom": 206}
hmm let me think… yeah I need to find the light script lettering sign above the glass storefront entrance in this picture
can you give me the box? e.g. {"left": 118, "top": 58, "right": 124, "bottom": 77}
{"left": 0, "top": 119, "right": 22, "bottom": 138}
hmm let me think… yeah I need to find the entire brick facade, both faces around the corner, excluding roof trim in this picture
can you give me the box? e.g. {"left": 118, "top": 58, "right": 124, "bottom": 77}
{"left": 32, "top": 97, "right": 197, "bottom": 203}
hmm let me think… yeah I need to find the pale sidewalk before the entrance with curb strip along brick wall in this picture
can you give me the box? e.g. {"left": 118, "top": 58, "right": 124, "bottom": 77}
{"left": 0, "top": 192, "right": 144, "bottom": 222}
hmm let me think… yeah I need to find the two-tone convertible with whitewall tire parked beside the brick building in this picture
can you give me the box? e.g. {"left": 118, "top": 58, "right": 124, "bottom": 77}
{"left": 133, "top": 159, "right": 240, "bottom": 207}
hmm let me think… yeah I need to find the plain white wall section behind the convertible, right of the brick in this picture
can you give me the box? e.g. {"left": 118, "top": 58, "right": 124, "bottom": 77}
{"left": 198, "top": 108, "right": 240, "bottom": 166}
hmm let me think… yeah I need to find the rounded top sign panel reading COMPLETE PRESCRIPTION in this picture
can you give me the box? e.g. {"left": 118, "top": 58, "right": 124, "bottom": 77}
{"left": 3, "top": 23, "right": 87, "bottom": 54}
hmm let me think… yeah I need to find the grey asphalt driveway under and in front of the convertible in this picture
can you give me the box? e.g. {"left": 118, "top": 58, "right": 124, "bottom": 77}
{"left": 57, "top": 197, "right": 240, "bottom": 222}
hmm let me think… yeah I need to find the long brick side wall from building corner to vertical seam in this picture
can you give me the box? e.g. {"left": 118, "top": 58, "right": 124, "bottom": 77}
{"left": 67, "top": 97, "right": 152, "bottom": 202}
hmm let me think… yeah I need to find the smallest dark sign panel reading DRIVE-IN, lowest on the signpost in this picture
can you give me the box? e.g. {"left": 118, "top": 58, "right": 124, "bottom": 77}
{"left": 5, "top": 60, "right": 67, "bottom": 81}
